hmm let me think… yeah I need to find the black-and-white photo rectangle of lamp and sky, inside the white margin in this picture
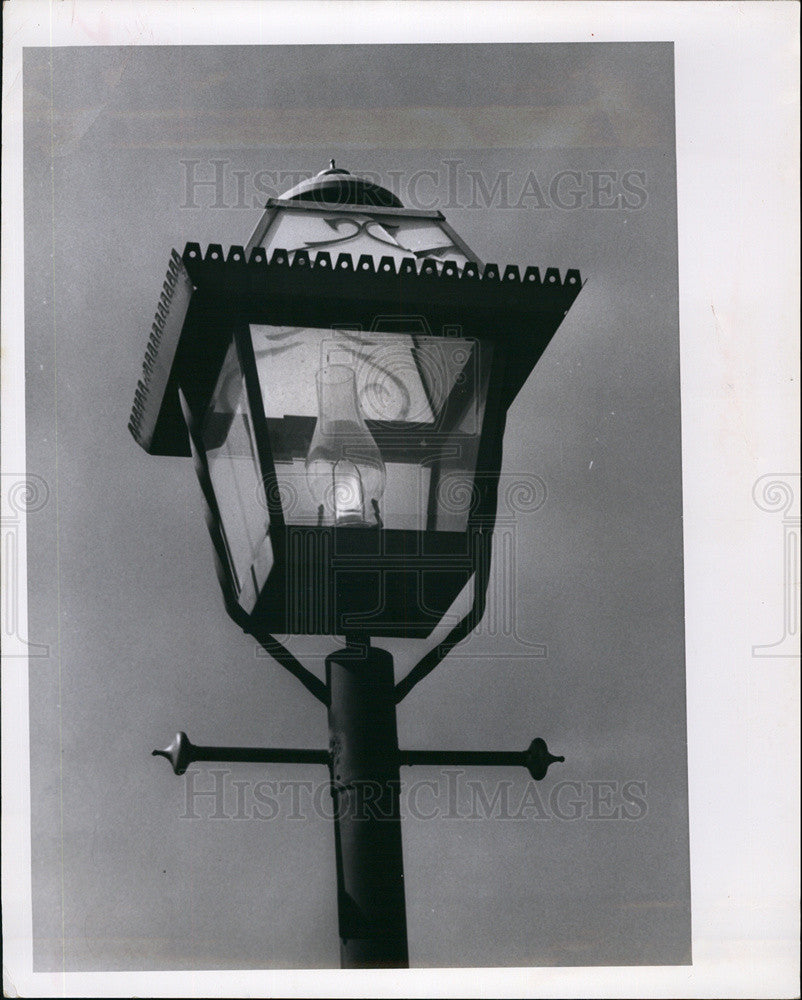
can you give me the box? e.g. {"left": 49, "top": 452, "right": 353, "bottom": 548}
{"left": 4, "top": 5, "right": 798, "bottom": 995}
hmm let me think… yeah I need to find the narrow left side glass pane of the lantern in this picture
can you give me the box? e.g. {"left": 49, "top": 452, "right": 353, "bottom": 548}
{"left": 201, "top": 342, "right": 273, "bottom": 612}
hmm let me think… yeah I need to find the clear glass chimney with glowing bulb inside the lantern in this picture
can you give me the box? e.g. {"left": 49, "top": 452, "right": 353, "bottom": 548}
{"left": 306, "top": 365, "right": 386, "bottom": 527}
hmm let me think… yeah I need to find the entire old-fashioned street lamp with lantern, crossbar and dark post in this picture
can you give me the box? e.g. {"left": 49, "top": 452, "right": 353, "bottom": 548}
{"left": 129, "top": 161, "right": 581, "bottom": 968}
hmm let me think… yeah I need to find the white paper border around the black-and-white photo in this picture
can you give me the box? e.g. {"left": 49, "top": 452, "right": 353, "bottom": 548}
{"left": 2, "top": 0, "right": 799, "bottom": 997}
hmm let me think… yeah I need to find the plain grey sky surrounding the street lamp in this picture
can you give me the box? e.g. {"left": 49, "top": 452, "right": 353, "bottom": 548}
{"left": 23, "top": 44, "right": 690, "bottom": 970}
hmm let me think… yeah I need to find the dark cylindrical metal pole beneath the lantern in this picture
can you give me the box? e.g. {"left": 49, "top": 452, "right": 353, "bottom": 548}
{"left": 326, "top": 638, "right": 409, "bottom": 969}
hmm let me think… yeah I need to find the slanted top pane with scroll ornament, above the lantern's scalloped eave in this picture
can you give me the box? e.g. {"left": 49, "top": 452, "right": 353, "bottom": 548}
{"left": 262, "top": 208, "right": 468, "bottom": 268}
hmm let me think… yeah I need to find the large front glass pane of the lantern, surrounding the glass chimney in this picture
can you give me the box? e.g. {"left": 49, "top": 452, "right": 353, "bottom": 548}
{"left": 251, "top": 321, "right": 492, "bottom": 531}
